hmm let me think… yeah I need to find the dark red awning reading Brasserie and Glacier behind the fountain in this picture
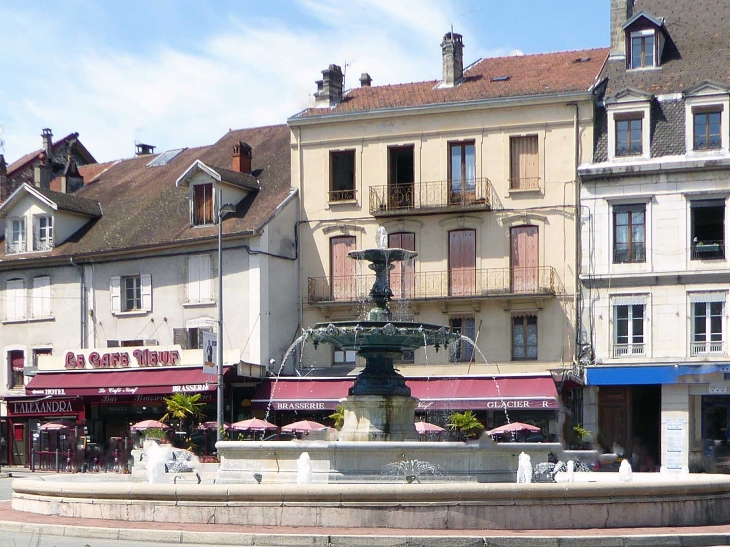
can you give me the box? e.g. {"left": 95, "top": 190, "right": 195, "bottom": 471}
{"left": 251, "top": 377, "right": 559, "bottom": 410}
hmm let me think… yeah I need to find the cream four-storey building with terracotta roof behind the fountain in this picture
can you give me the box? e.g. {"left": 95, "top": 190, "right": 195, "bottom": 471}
{"left": 266, "top": 33, "right": 607, "bottom": 437}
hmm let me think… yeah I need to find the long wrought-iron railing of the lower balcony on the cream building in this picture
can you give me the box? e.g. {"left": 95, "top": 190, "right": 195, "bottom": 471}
{"left": 307, "top": 266, "right": 564, "bottom": 304}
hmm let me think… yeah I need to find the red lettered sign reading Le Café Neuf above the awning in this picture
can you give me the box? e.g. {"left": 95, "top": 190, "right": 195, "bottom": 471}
{"left": 64, "top": 346, "right": 182, "bottom": 370}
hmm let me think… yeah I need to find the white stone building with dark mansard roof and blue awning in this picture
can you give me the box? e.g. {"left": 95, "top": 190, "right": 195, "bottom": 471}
{"left": 579, "top": 0, "right": 730, "bottom": 470}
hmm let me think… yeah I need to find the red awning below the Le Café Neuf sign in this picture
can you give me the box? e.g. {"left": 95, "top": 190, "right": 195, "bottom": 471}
{"left": 25, "top": 367, "right": 232, "bottom": 395}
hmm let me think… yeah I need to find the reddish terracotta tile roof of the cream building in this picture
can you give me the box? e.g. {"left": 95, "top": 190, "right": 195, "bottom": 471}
{"left": 293, "top": 48, "right": 608, "bottom": 119}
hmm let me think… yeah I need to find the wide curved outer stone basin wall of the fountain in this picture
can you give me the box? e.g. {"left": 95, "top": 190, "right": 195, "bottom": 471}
{"left": 12, "top": 474, "right": 730, "bottom": 531}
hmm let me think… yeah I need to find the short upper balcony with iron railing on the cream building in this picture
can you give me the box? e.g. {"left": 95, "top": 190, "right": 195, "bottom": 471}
{"left": 370, "top": 178, "right": 497, "bottom": 217}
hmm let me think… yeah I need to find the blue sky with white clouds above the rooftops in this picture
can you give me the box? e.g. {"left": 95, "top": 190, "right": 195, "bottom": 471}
{"left": 0, "top": 0, "right": 609, "bottom": 163}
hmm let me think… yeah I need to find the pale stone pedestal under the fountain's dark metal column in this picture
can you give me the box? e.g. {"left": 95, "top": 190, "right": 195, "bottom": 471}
{"left": 339, "top": 395, "right": 418, "bottom": 441}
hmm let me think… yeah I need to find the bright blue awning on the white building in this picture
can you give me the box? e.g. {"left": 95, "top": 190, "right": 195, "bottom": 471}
{"left": 586, "top": 363, "right": 730, "bottom": 386}
